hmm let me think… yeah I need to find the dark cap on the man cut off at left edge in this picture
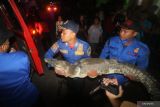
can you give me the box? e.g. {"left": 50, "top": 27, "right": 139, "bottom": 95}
{"left": 0, "top": 28, "right": 13, "bottom": 45}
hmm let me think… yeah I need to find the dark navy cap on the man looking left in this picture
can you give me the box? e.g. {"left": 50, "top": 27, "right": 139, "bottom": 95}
{"left": 62, "top": 20, "right": 79, "bottom": 33}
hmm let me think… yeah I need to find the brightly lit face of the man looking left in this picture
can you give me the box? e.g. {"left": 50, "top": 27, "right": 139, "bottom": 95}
{"left": 61, "top": 29, "right": 75, "bottom": 42}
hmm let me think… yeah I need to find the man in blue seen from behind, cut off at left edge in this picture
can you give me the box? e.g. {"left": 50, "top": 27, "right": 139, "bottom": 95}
{"left": 0, "top": 27, "right": 38, "bottom": 107}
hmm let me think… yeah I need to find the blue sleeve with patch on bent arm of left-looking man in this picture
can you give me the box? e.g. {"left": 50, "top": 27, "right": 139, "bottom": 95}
{"left": 44, "top": 42, "right": 59, "bottom": 58}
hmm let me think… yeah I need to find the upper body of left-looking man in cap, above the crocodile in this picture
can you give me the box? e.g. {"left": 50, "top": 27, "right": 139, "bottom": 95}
{"left": 45, "top": 20, "right": 91, "bottom": 64}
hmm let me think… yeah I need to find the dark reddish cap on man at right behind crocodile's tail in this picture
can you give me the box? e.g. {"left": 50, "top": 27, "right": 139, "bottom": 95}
{"left": 121, "top": 20, "right": 140, "bottom": 32}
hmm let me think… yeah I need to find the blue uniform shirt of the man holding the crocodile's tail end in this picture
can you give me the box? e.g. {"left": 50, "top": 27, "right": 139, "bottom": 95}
{"left": 100, "top": 36, "right": 150, "bottom": 82}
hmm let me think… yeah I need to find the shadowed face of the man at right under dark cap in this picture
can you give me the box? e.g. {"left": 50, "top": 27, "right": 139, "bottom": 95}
{"left": 120, "top": 28, "right": 137, "bottom": 40}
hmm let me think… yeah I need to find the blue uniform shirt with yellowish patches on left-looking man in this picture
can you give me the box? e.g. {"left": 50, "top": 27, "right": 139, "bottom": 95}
{"left": 45, "top": 39, "right": 91, "bottom": 64}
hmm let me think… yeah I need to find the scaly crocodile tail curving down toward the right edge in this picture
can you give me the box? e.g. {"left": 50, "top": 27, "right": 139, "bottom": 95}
{"left": 102, "top": 61, "right": 160, "bottom": 100}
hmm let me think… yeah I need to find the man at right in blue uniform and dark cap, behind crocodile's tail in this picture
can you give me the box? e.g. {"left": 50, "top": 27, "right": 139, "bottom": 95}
{"left": 100, "top": 20, "right": 150, "bottom": 84}
